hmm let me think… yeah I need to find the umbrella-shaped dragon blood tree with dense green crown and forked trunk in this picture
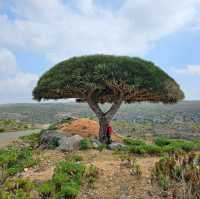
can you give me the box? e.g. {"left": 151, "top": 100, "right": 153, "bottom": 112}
{"left": 33, "top": 55, "right": 184, "bottom": 142}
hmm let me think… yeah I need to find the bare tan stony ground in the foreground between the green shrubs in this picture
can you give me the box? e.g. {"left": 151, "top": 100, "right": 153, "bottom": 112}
{"left": 19, "top": 150, "right": 170, "bottom": 199}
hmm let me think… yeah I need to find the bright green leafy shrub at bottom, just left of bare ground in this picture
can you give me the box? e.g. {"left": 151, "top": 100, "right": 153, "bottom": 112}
{"left": 38, "top": 161, "right": 85, "bottom": 199}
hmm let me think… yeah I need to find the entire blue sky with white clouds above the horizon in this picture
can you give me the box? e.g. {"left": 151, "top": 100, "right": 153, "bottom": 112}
{"left": 0, "top": 0, "right": 200, "bottom": 103}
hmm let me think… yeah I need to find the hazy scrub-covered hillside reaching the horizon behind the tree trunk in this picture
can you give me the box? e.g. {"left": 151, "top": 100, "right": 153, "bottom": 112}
{"left": 0, "top": 101, "right": 200, "bottom": 139}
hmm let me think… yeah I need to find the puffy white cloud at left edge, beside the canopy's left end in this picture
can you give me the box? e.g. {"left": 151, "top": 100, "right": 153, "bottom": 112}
{"left": 0, "top": 49, "right": 38, "bottom": 103}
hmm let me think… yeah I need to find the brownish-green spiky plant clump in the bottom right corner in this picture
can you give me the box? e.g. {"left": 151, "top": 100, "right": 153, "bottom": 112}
{"left": 152, "top": 152, "right": 200, "bottom": 198}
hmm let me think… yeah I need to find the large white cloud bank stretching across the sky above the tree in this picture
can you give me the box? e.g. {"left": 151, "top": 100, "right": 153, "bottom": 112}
{"left": 0, "top": 0, "right": 199, "bottom": 62}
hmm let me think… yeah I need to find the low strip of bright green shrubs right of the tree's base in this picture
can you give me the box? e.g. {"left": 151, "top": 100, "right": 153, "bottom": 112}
{"left": 124, "top": 137, "right": 200, "bottom": 155}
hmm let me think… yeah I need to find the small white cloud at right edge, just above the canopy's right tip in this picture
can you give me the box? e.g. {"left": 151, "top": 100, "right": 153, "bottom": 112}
{"left": 175, "top": 65, "right": 200, "bottom": 76}
